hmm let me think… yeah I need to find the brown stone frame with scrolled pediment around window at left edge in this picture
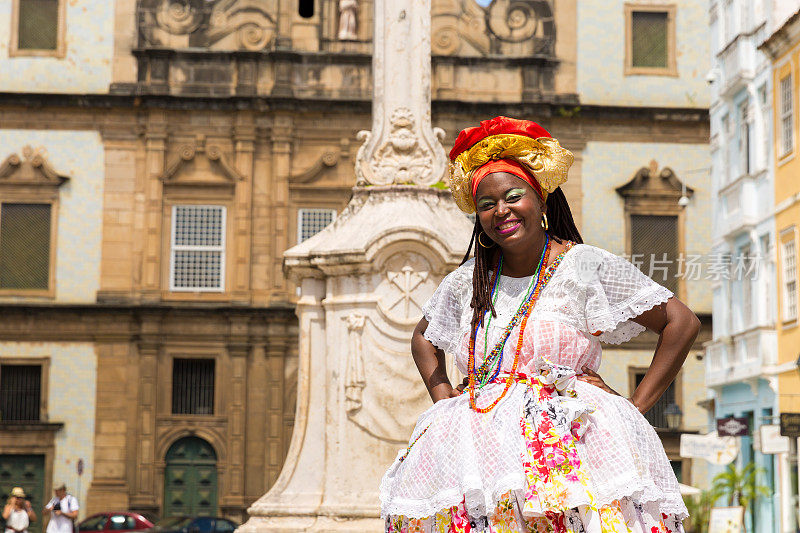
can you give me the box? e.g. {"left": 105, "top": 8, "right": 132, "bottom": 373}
{"left": 0, "top": 150, "right": 69, "bottom": 299}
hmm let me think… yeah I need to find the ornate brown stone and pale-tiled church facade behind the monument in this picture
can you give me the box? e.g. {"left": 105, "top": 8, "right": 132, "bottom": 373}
{"left": 0, "top": 0, "right": 711, "bottom": 521}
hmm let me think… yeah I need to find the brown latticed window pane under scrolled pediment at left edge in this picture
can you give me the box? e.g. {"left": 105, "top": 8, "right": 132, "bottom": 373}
{"left": 0, "top": 203, "right": 51, "bottom": 290}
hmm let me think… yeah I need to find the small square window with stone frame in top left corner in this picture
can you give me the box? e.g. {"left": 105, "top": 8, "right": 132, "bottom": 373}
{"left": 11, "top": 0, "right": 66, "bottom": 57}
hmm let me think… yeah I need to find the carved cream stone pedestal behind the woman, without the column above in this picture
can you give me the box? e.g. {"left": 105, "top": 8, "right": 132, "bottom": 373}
{"left": 240, "top": 186, "right": 472, "bottom": 532}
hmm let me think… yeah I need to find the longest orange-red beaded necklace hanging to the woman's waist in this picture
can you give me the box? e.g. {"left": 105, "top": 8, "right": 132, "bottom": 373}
{"left": 467, "top": 233, "right": 550, "bottom": 413}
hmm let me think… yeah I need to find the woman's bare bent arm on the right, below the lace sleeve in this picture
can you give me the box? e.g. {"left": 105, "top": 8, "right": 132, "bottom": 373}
{"left": 630, "top": 298, "right": 700, "bottom": 413}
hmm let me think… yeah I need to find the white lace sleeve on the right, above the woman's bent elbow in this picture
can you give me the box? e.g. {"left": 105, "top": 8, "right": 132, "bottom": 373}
{"left": 583, "top": 246, "right": 673, "bottom": 344}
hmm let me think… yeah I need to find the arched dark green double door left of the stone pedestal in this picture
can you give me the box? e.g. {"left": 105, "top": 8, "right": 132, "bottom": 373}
{"left": 164, "top": 437, "right": 217, "bottom": 517}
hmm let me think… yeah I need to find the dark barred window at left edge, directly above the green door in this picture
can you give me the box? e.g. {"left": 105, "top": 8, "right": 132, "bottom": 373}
{"left": 0, "top": 365, "right": 42, "bottom": 422}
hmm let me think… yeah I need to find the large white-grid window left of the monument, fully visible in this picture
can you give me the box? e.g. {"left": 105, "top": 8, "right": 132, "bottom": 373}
{"left": 170, "top": 205, "right": 226, "bottom": 292}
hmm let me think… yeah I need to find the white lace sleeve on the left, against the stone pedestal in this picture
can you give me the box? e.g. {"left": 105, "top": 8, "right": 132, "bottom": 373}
{"left": 422, "top": 263, "right": 471, "bottom": 354}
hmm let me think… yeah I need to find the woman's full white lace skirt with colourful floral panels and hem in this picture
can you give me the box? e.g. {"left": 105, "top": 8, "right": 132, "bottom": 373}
{"left": 381, "top": 365, "right": 686, "bottom": 533}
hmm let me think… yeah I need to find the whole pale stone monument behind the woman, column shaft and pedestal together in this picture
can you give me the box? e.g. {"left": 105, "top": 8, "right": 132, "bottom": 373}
{"left": 239, "top": 0, "right": 472, "bottom": 533}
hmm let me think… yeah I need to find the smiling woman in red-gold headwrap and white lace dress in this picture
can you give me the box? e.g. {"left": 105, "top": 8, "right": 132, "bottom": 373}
{"left": 381, "top": 117, "right": 700, "bottom": 533}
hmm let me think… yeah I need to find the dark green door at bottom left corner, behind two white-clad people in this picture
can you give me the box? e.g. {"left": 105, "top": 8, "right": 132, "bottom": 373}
{"left": 0, "top": 455, "right": 47, "bottom": 533}
